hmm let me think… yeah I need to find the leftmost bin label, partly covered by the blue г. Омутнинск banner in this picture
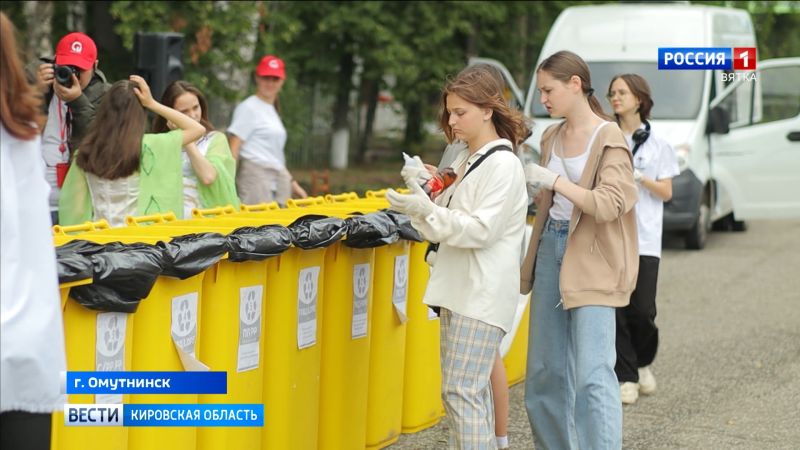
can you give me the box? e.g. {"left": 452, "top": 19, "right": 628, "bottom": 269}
{"left": 94, "top": 313, "right": 128, "bottom": 404}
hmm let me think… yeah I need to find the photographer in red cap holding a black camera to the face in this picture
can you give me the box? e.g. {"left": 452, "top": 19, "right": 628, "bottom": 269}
{"left": 36, "top": 33, "right": 109, "bottom": 224}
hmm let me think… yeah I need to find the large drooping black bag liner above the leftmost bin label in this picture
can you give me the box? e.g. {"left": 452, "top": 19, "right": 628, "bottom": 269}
{"left": 70, "top": 242, "right": 163, "bottom": 313}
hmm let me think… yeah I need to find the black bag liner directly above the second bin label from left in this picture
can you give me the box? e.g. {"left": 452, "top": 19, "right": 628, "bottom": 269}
{"left": 157, "top": 233, "right": 228, "bottom": 280}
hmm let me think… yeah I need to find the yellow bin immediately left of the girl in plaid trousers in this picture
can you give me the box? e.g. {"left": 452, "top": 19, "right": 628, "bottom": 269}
{"left": 403, "top": 242, "right": 444, "bottom": 433}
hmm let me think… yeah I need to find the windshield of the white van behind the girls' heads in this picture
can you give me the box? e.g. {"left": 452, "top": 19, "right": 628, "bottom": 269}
{"left": 533, "top": 62, "right": 705, "bottom": 120}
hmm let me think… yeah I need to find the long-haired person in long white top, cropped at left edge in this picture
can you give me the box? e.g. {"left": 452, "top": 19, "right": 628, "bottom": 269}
{"left": 0, "top": 12, "right": 67, "bottom": 450}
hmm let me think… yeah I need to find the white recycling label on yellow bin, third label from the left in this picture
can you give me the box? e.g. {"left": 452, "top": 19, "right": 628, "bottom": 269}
{"left": 236, "top": 284, "right": 264, "bottom": 372}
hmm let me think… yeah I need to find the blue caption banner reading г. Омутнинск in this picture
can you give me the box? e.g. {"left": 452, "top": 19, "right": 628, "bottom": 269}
{"left": 65, "top": 372, "right": 228, "bottom": 394}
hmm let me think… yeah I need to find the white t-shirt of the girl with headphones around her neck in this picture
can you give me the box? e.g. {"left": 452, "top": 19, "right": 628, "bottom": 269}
{"left": 625, "top": 124, "right": 680, "bottom": 258}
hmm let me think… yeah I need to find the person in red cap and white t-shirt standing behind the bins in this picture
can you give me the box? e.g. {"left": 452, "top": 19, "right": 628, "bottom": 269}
{"left": 228, "top": 55, "right": 307, "bottom": 204}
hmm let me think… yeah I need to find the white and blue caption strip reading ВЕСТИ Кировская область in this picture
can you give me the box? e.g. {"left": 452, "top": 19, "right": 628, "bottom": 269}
{"left": 64, "top": 403, "right": 264, "bottom": 427}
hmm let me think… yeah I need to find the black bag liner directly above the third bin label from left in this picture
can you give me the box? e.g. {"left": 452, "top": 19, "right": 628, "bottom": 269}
{"left": 228, "top": 225, "right": 292, "bottom": 262}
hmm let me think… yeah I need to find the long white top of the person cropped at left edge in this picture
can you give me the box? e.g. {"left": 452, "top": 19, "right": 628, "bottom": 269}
{"left": 0, "top": 125, "right": 67, "bottom": 413}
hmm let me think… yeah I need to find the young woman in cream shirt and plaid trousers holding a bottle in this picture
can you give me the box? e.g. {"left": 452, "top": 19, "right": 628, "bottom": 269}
{"left": 386, "top": 65, "right": 528, "bottom": 449}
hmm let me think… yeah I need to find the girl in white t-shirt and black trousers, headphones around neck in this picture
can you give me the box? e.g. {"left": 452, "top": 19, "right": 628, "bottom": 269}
{"left": 608, "top": 74, "right": 680, "bottom": 404}
